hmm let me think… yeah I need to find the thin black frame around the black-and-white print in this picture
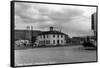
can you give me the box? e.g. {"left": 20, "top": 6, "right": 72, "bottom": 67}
{"left": 10, "top": 1, "right": 98, "bottom": 67}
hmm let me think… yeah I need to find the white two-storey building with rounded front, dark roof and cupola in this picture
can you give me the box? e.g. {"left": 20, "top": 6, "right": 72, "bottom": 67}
{"left": 37, "top": 27, "right": 67, "bottom": 46}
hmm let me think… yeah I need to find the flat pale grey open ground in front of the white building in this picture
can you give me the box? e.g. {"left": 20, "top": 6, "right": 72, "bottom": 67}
{"left": 15, "top": 45, "right": 96, "bottom": 66}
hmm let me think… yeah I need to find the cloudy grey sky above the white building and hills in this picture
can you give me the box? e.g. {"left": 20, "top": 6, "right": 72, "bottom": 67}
{"left": 14, "top": 2, "right": 96, "bottom": 37}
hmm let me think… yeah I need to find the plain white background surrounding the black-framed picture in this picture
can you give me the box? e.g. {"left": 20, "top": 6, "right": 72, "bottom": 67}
{"left": 0, "top": 0, "right": 100, "bottom": 68}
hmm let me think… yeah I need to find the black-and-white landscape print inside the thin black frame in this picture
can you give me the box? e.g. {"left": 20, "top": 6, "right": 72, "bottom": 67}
{"left": 12, "top": 1, "right": 98, "bottom": 66}
